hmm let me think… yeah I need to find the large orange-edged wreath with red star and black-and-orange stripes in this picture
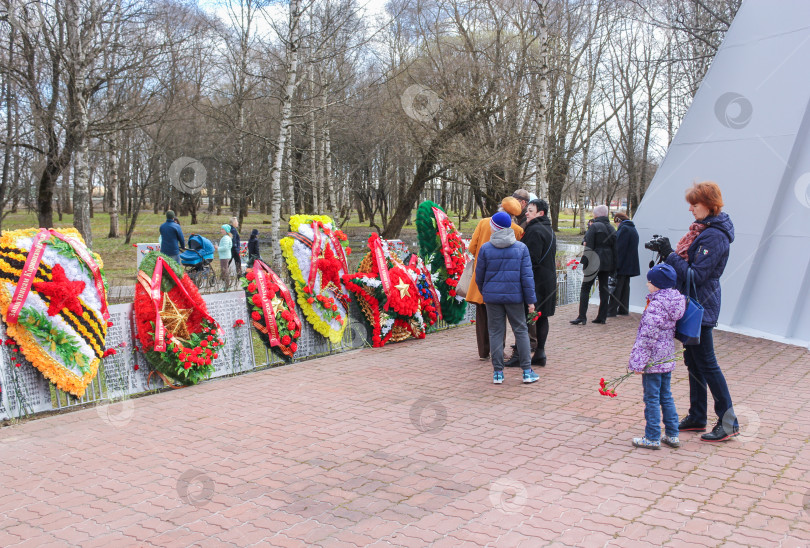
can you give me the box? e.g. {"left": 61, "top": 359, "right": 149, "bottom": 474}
{"left": 0, "top": 228, "right": 110, "bottom": 398}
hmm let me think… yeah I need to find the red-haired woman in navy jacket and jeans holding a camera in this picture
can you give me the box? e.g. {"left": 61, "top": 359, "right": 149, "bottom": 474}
{"left": 648, "top": 182, "right": 740, "bottom": 441}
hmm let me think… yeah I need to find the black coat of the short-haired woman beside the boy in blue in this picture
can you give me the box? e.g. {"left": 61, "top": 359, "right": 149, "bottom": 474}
{"left": 520, "top": 215, "right": 557, "bottom": 317}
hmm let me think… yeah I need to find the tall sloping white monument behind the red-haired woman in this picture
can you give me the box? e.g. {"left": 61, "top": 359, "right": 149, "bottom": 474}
{"left": 631, "top": 0, "right": 810, "bottom": 346}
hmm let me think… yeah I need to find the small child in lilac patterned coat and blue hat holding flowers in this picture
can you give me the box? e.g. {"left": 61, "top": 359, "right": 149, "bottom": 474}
{"left": 627, "top": 264, "right": 686, "bottom": 449}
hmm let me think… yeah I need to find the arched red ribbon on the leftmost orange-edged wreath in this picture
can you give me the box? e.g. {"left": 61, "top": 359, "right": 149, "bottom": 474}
{"left": 8, "top": 228, "right": 110, "bottom": 323}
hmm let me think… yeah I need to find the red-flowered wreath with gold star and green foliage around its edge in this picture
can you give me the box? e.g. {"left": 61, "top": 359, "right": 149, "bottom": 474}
{"left": 133, "top": 251, "right": 225, "bottom": 385}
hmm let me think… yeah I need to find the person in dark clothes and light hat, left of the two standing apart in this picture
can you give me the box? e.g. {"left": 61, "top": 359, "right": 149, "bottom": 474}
{"left": 571, "top": 205, "right": 617, "bottom": 325}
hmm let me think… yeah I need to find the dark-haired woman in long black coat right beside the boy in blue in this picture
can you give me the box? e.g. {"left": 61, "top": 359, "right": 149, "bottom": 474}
{"left": 521, "top": 199, "right": 557, "bottom": 366}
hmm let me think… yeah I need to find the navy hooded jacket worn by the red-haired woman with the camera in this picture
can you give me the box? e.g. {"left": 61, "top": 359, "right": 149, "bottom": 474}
{"left": 666, "top": 213, "right": 734, "bottom": 326}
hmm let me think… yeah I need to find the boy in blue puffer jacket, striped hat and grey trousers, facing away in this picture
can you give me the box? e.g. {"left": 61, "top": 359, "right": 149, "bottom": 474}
{"left": 475, "top": 211, "right": 540, "bottom": 384}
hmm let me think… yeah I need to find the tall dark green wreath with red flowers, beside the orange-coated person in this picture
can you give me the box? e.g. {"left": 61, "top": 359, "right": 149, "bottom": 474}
{"left": 416, "top": 200, "right": 467, "bottom": 324}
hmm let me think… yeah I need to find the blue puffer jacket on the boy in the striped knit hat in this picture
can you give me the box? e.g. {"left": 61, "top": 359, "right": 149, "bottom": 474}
{"left": 475, "top": 228, "right": 537, "bottom": 304}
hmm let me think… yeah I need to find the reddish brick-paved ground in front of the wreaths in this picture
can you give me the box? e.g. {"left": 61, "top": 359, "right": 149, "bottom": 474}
{"left": 0, "top": 307, "right": 810, "bottom": 547}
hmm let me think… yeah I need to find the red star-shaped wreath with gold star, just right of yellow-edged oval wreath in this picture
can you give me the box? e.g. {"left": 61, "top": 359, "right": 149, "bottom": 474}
{"left": 343, "top": 234, "right": 425, "bottom": 347}
